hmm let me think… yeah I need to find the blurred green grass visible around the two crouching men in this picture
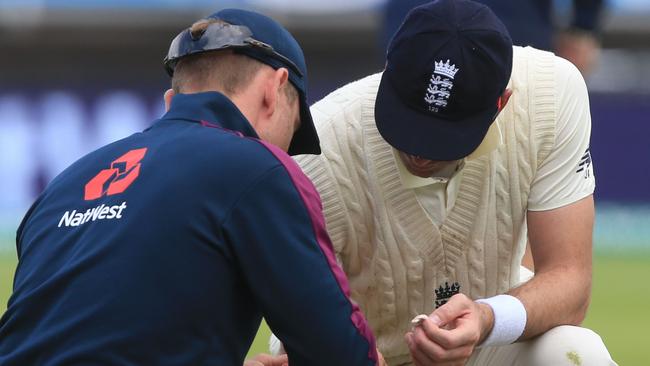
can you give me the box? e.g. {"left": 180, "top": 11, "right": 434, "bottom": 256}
{"left": 0, "top": 252, "right": 650, "bottom": 365}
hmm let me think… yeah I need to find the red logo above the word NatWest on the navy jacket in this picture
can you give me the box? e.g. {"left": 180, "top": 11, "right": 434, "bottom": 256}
{"left": 84, "top": 147, "right": 147, "bottom": 201}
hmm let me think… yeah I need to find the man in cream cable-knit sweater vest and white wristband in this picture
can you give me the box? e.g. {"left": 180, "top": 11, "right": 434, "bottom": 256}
{"left": 268, "top": 0, "right": 615, "bottom": 366}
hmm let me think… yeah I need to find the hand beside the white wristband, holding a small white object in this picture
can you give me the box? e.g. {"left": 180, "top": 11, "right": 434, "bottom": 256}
{"left": 405, "top": 294, "right": 494, "bottom": 366}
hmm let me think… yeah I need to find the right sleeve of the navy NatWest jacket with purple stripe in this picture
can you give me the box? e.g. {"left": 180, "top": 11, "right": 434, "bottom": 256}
{"left": 223, "top": 160, "right": 377, "bottom": 366}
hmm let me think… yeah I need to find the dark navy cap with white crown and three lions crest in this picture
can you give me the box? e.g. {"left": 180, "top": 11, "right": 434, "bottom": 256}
{"left": 375, "top": 0, "right": 512, "bottom": 160}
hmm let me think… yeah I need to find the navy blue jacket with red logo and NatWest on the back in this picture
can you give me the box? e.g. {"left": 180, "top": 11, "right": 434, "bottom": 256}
{"left": 0, "top": 93, "right": 376, "bottom": 366}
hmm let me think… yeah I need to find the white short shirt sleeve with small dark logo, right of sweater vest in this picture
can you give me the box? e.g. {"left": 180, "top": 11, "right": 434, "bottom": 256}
{"left": 528, "top": 57, "right": 596, "bottom": 211}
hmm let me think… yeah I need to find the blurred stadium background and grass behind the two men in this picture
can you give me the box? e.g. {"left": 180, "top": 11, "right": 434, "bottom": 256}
{"left": 0, "top": 0, "right": 650, "bottom": 365}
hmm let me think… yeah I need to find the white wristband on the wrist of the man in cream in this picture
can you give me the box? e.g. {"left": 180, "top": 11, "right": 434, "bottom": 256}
{"left": 476, "top": 295, "right": 527, "bottom": 347}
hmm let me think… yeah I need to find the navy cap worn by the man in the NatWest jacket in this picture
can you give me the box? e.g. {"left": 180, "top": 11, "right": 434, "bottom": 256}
{"left": 165, "top": 9, "right": 321, "bottom": 155}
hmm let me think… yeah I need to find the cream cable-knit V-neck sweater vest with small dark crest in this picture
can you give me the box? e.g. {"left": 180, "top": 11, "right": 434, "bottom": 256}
{"left": 297, "top": 47, "right": 556, "bottom": 364}
